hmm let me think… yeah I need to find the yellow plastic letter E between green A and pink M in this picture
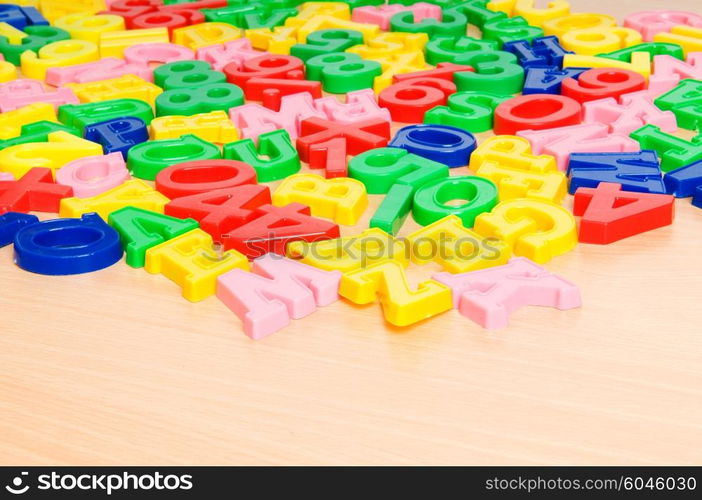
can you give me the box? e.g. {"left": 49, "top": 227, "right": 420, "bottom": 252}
{"left": 144, "top": 229, "right": 249, "bottom": 302}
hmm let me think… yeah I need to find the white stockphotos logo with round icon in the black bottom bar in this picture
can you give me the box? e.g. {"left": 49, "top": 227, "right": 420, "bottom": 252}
{"left": 5, "top": 471, "right": 193, "bottom": 496}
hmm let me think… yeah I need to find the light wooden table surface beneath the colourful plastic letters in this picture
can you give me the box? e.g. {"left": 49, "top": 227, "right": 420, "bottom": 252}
{"left": 0, "top": 0, "right": 702, "bottom": 465}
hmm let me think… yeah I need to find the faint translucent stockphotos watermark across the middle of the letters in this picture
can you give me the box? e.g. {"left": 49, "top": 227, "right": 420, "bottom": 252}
{"left": 203, "top": 233, "right": 502, "bottom": 267}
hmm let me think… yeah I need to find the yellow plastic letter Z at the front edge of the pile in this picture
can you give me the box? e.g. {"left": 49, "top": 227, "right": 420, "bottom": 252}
{"left": 339, "top": 260, "right": 452, "bottom": 326}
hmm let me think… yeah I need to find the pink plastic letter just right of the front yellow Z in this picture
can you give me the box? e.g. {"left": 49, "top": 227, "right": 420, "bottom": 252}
{"left": 433, "top": 258, "right": 582, "bottom": 329}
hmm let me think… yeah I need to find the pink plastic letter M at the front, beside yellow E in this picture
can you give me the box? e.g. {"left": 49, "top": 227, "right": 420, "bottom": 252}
{"left": 217, "top": 254, "right": 341, "bottom": 340}
